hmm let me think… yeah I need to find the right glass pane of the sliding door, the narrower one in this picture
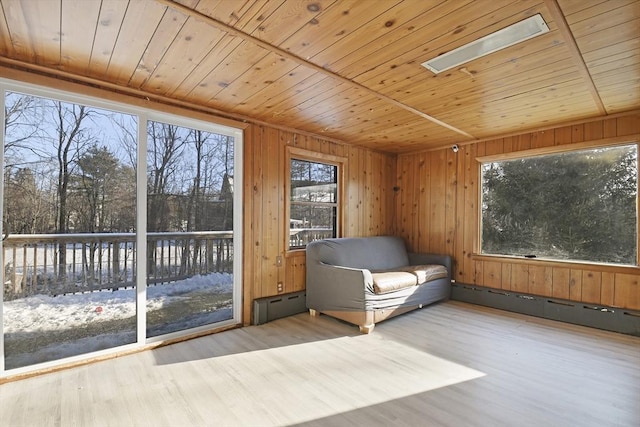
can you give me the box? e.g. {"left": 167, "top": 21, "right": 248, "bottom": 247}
{"left": 147, "top": 122, "right": 234, "bottom": 337}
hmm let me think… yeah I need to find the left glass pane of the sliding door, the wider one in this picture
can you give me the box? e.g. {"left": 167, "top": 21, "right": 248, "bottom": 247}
{"left": 2, "top": 92, "right": 137, "bottom": 369}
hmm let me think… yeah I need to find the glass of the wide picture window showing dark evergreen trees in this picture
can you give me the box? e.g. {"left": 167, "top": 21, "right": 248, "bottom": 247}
{"left": 482, "top": 144, "right": 638, "bottom": 264}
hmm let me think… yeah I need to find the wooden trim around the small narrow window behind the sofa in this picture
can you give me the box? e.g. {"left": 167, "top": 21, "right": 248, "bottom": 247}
{"left": 282, "top": 147, "right": 347, "bottom": 254}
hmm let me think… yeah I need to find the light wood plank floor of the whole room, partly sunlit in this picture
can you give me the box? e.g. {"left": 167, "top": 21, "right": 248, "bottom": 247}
{"left": 0, "top": 302, "right": 640, "bottom": 427}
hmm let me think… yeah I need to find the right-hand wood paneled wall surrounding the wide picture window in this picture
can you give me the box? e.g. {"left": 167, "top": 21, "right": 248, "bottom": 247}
{"left": 396, "top": 112, "right": 640, "bottom": 310}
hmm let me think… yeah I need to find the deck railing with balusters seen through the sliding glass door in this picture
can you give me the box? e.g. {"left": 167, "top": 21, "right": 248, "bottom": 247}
{"left": 3, "top": 231, "right": 233, "bottom": 300}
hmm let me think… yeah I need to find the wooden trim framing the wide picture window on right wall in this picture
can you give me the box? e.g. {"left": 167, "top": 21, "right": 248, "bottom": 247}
{"left": 472, "top": 133, "right": 640, "bottom": 272}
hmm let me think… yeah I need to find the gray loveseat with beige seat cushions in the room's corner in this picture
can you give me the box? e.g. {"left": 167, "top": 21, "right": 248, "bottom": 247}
{"left": 306, "top": 236, "right": 452, "bottom": 333}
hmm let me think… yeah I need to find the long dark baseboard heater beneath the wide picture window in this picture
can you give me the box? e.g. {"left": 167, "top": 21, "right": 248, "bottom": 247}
{"left": 451, "top": 283, "right": 640, "bottom": 336}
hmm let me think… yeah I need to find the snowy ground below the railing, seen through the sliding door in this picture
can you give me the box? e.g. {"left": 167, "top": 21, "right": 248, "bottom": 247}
{"left": 3, "top": 273, "right": 233, "bottom": 369}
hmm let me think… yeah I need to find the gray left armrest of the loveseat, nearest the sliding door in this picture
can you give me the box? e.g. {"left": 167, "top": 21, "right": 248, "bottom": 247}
{"left": 306, "top": 262, "right": 373, "bottom": 311}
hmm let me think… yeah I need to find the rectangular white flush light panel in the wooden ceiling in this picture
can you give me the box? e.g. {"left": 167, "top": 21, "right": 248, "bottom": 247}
{"left": 422, "top": 14, "right": 549, "bottom": 74}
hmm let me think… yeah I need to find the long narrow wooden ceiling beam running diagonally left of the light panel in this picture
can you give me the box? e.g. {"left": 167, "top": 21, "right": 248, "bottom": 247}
{"left": 156, "top": 0, "right": 476, "bottom": 139}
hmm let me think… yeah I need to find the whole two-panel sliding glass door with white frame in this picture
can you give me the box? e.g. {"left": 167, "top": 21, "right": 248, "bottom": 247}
{"left": 0, "top": 79, "right": 242, "bottom": 376}
